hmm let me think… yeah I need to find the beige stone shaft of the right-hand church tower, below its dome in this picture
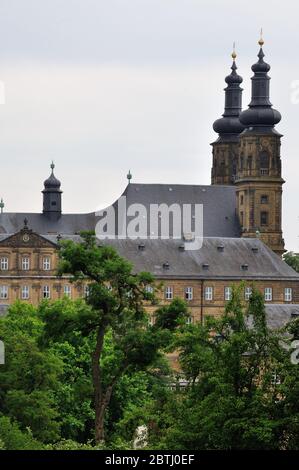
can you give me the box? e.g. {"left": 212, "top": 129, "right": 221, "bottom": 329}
{"left": 236, "top": 134, "right": 284, "bottom": 255}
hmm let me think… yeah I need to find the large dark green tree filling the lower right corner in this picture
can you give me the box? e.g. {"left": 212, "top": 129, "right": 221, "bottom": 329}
{"left": 145, "top": 286, "right": 299, "bottom": 450}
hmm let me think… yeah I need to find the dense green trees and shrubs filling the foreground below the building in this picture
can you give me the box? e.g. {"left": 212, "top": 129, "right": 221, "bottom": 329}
{"left": 0, "top": 238, "right": 299, "bottom": 450}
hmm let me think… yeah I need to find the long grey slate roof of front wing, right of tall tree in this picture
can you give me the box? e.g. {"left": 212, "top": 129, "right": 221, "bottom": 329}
{"left": 102, "top": 237, "right": 299, "bottom": 281}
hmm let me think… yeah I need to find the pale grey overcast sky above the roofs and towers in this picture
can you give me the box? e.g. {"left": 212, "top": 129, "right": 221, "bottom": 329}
{"left": 0, "top": 0, "right": 299, "bottom": 251}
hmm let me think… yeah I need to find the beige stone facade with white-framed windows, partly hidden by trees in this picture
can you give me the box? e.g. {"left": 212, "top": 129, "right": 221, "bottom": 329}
{"left": 0, "top": 247, "right": 299, "bottom": 322}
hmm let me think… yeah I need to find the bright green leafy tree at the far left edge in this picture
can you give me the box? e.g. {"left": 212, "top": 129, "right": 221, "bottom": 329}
{"left": 0, "top": 302, "right": 63, "bottom": 442}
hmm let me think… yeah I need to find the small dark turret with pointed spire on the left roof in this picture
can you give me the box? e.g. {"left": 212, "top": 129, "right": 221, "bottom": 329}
{"left": 42, "top": 162, "right": 62, "bottom": 220}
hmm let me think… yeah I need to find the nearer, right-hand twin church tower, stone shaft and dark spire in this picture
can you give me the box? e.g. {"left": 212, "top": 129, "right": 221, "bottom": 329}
{"left": 235, "top": 37, "right": 285, "bottom": 255}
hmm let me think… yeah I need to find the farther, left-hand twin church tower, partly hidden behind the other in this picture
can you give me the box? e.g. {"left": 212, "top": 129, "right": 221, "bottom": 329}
{"left": 212, "top": 48, "right": 244, "bottom": 184}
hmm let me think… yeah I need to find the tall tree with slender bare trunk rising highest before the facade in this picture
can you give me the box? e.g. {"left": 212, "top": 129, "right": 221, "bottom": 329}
{"left": 43, "top": 233, "right": 184, "bottom": 444}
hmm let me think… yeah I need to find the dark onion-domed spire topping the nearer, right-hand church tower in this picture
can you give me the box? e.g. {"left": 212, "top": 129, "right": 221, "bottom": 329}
{"left": 240, "top": 30, "right": 281, "bottom": 133}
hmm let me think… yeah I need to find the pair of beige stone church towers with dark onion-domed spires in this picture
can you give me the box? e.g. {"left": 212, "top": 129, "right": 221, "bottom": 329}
{"left": 212, "top": 38, "right": 285, "bottom": 255}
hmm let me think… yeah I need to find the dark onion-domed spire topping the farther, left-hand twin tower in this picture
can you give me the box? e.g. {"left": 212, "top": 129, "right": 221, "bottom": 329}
{"left": 213, "top": 43, "right": 244, "bottom": 141}
